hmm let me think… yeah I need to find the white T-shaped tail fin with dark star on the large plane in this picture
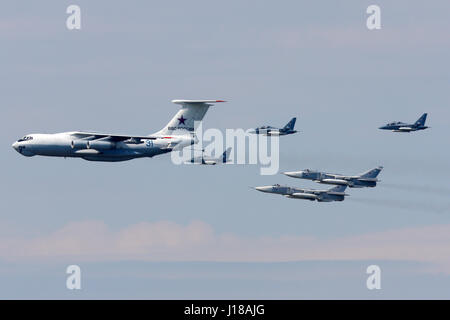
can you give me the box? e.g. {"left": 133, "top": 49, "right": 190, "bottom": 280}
{"left": 153, "top": 100, "right": 225, "bottom": 136}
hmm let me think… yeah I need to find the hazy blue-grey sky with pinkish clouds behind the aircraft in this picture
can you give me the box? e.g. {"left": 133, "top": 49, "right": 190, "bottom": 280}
{"left": 0, "top": 0, "right": 450, "bottom": 299}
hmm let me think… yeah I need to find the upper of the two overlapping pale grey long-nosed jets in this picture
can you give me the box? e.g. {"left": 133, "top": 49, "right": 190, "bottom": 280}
{"left": 283, "top": 166, "right": 383, "bottom": 188}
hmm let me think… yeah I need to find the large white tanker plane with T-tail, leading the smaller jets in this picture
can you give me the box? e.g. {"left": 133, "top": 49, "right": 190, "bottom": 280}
{"left": 12, "top": 100, "right": 225, "bottom": 162}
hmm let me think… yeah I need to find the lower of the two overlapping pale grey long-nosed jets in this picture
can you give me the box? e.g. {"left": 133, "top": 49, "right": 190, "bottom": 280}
{"left": 255, "top": 184, "right": 348, "bottom": 202}
